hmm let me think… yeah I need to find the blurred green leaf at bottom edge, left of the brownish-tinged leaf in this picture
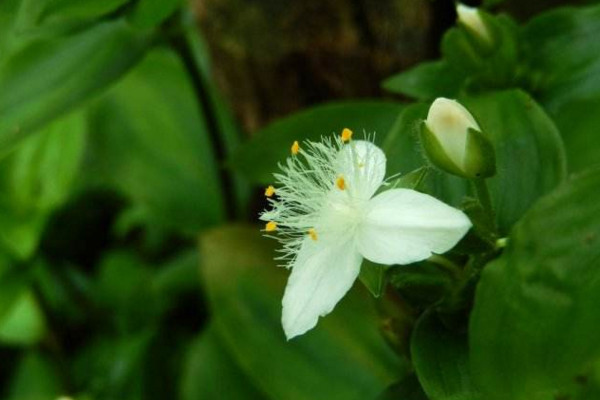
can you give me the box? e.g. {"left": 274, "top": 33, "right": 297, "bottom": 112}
{"left": 180, "top": 325, "right": 267, "bottom": 400}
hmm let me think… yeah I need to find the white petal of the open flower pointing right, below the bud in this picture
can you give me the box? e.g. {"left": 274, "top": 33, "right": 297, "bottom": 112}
{"left": 356, "top": 189, "right": 471, "bottom": 265}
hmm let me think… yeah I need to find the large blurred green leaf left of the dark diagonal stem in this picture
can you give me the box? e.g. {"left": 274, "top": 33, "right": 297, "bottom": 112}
{"left": 88, "top": 49, "right": 224, "bottom": 233}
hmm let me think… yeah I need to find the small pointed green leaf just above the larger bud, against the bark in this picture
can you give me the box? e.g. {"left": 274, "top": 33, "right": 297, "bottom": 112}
{"left": 382, "top": 61, "right": 466, "bottom": 101}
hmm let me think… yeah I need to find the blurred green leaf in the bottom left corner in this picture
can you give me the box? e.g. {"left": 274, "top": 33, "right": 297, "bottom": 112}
{"left": 8, "top": 351, "right": 66, "bottom": 400}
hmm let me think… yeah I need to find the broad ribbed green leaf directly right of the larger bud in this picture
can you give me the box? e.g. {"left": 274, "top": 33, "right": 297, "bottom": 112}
{"left": 461, "top": 90, "right": 566, "bottom": 234}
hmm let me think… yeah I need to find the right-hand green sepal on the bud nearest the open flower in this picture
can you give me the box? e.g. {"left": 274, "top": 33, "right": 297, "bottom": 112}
{"left": 464, "top": 128, "right": 496, "bottom": 179}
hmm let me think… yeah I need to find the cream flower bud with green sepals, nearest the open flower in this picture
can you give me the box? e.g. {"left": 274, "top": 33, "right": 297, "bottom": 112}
{"left": 421, "top": 97, "right": 496, "bottom": 179}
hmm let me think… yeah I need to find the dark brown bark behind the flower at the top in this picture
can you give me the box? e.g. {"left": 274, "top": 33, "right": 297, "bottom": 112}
{"left": 195, "top": 0, "right": 435, "bottom": 131}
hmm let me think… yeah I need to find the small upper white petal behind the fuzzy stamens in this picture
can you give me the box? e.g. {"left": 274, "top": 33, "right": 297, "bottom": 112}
{"left": 336, "top": 140, "right": 386, "bottom": 200}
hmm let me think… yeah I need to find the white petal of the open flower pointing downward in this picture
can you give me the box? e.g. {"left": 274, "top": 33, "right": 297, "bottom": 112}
{"left": 282, "top": 237, "right": 362, "bottom": 340}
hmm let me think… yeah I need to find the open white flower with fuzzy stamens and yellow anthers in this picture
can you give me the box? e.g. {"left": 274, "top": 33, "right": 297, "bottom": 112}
{"left": 261, "top": 132, "right": 471, "bottom": 339}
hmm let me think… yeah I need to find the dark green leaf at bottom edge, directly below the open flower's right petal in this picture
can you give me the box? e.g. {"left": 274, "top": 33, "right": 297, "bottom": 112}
{"left": 411, "top": 311, "right": 480, "bottom": 400}
